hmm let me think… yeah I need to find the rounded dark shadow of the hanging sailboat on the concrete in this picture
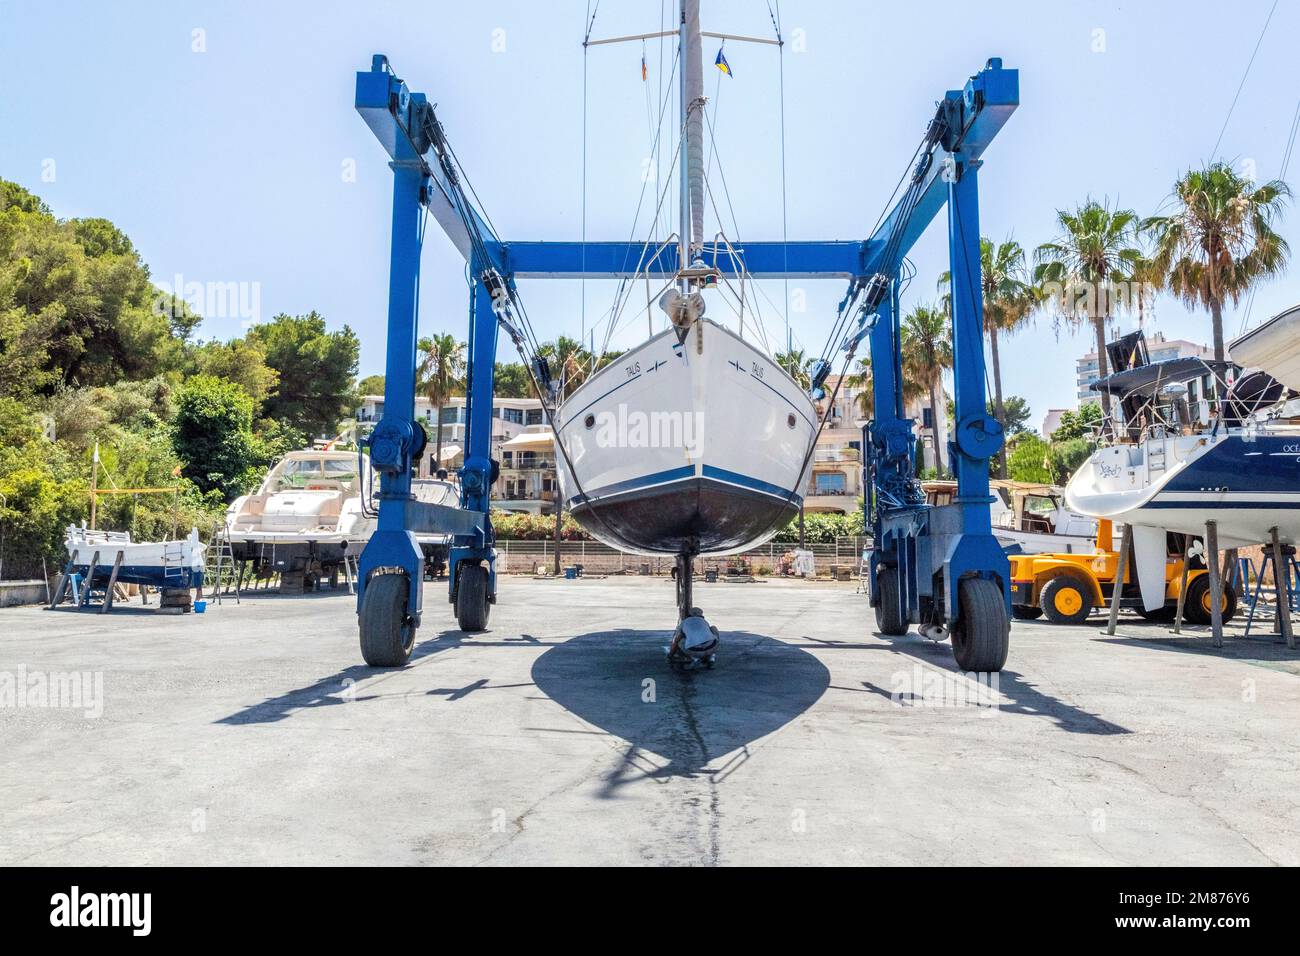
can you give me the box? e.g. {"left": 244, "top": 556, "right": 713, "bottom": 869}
{"left": 532, "top": 630, "right": 831, "bottom": 796}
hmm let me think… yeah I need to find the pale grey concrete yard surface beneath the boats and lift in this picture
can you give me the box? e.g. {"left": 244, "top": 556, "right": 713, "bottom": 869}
{"left": 0, "top": 578, "right": 1300, "bottom": 865}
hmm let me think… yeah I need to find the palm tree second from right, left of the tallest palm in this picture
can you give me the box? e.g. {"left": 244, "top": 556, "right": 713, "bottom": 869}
{"left": 1034, "top": 199, "right": 1143, "bottom": 418}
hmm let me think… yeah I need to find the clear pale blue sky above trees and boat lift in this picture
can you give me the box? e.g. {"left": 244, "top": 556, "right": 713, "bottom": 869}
{"left": 0, "top": 0, "right": 1300, "bottom": 424}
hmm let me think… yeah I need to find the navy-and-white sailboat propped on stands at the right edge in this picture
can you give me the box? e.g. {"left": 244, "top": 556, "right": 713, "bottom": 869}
{"left": 1066, "top": 327, "right": 1300, "bottom": 610}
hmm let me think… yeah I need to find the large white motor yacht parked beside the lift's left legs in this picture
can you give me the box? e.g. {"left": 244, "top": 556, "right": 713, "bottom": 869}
{"left": 226, "top": 449, "right": 376, "bottom": 584}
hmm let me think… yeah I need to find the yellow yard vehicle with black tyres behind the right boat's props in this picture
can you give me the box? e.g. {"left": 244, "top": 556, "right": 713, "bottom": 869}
{"left": 1008, "top": 519, "right": 1236, "bottom": 624}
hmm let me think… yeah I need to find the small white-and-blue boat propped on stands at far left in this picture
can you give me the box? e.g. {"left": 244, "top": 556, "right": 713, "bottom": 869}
{"left": 64, "top": 525, "right": 207, "bottom": 589}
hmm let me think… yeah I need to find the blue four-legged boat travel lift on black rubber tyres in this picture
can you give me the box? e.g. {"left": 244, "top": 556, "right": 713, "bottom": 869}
{"left": 356, "top": 55, "right": 1019, "bottom": 671}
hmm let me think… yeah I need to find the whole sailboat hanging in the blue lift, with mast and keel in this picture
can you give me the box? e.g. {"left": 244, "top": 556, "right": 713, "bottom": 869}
{"left": 554, "top": 0, "right": 819, "bottom": 665}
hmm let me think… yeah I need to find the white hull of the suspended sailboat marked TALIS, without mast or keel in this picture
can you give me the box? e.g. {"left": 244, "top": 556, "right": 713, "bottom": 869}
{"left": 556, "top": 320, "right": 816, "bottom": 554}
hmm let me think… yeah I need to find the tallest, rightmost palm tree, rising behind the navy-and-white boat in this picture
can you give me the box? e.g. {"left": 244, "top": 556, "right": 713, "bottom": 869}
{"left": 1141, "top": 163, "right": 1291, "bottom": 362}
